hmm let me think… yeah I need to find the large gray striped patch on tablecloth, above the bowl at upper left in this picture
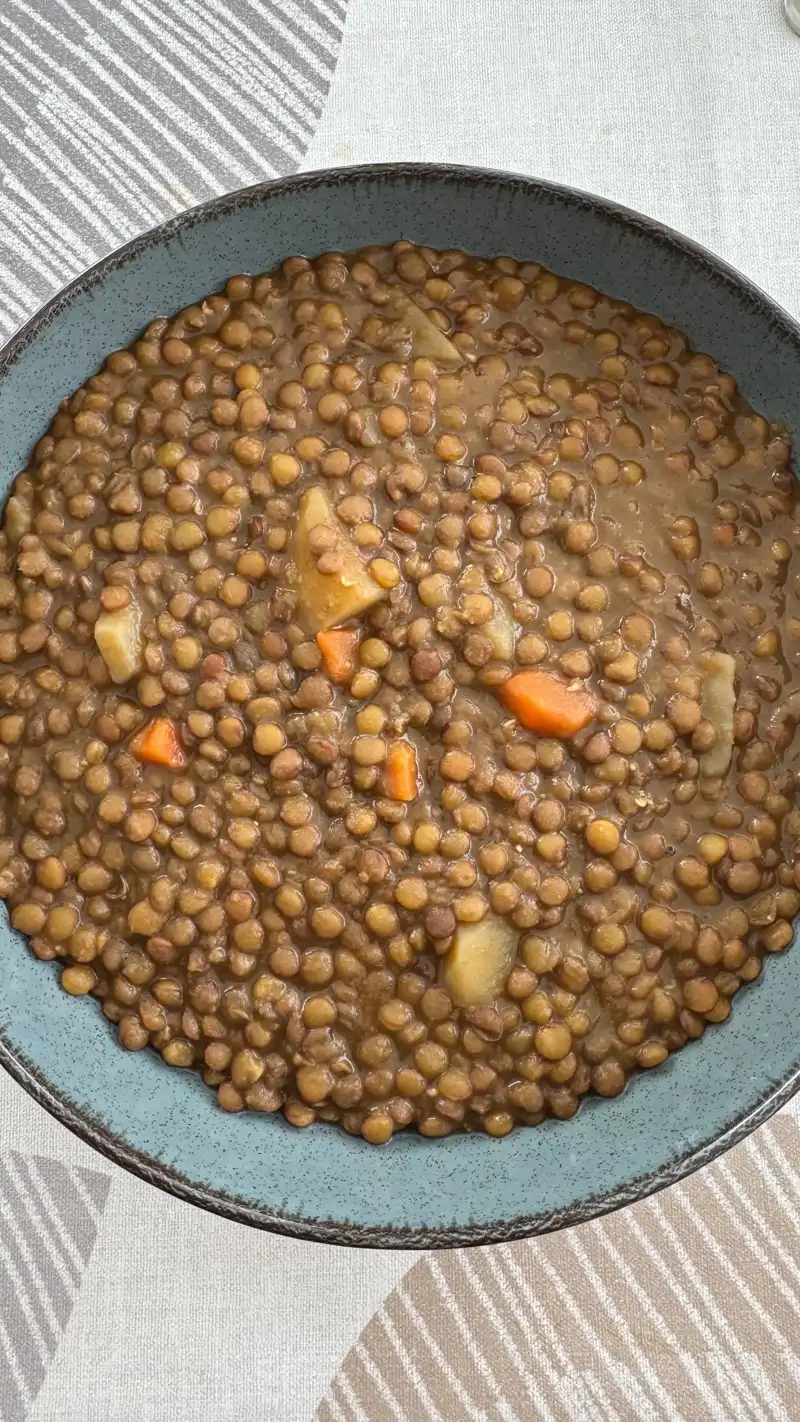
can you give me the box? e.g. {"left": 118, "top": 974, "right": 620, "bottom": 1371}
{"left": 0, "top": 0, "right": 347, "bottom": 340}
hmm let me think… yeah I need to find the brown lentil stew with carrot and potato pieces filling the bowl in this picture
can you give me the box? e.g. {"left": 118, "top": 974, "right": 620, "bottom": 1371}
{"left": 0, "top": 242, "right": 800, "bottom": 1143}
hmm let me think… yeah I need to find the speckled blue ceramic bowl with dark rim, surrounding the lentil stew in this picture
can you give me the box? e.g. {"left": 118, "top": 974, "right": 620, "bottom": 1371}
{"left": 0, "top": 166, "right": 800, "bottom": 1249}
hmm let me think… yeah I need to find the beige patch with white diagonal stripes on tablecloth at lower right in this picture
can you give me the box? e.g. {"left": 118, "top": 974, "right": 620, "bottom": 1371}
{"left": 315, "top": 1112, "right": 800, "bottom": 1422}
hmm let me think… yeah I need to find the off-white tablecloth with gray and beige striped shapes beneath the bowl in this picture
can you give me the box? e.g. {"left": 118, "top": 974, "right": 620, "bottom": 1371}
{"left": 0, "top": 0, "right": 800, "bottom": 1422}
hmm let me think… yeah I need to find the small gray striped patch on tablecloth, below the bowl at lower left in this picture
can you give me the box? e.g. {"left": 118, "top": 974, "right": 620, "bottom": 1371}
{"left": 0, "top": 1152, "right": 111, "bottom": 1422}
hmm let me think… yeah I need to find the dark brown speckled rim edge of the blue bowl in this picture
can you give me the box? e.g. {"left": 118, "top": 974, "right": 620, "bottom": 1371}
{"left": 0, "top": 162, "right": 800, "bottom": 1250}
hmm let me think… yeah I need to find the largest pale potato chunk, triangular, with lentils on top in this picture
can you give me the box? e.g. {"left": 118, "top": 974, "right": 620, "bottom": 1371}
{"left": 291, "top": 488, "right": 387, "bottom": 631}
